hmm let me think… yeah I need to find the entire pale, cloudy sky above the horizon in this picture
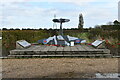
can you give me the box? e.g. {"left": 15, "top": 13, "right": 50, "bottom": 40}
{"left": 0, "top": 0, "right": 119, "bottom": 28}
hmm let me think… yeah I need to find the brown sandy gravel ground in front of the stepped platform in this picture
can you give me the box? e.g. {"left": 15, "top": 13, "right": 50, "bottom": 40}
{"left": 2, "top": 58, "right": 118, "bottom": 78}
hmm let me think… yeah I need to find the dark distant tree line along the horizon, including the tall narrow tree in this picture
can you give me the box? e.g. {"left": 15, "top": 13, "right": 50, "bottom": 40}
{"left": 0, "top": 19, "right": 120, "bottom": 31}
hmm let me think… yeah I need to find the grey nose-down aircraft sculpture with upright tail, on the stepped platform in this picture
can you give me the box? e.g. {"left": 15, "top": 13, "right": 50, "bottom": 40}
{"left": 38, "top": 18, "right": 86, "bottom": 46}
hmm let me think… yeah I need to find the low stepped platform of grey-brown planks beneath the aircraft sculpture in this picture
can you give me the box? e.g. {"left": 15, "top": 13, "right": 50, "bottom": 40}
{"left": 10, "top": 45, "right": 110, "bottom": 56}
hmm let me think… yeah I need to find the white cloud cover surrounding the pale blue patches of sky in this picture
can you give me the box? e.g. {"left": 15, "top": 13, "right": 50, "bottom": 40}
{"left": 0, "top": 0, "right": 118, "bottom": 27}
